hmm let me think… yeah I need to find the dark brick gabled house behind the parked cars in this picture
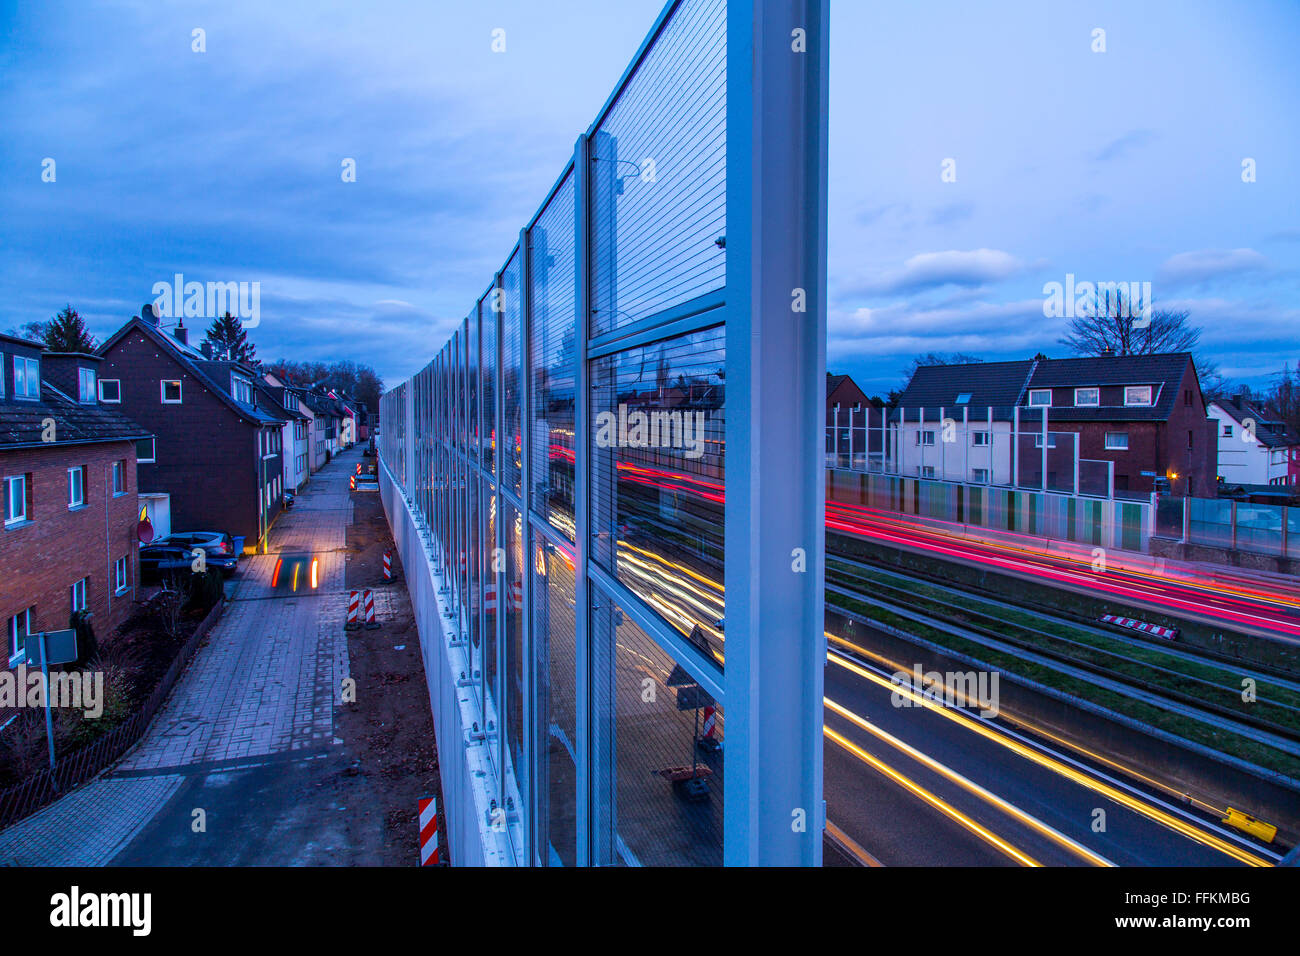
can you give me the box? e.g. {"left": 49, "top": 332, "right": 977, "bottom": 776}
{"left": 99, "top": 310, "right": 286, "bottom": 550}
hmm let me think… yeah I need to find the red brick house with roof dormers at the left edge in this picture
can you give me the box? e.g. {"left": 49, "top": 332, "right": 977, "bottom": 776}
{"left": 0, "top": 336, "right": 151, "bottom": 676}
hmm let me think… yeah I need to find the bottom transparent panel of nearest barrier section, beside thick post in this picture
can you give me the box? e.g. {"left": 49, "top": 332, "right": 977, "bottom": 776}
{"left": 590, "top": 594, "right": 724, "bottom": 866}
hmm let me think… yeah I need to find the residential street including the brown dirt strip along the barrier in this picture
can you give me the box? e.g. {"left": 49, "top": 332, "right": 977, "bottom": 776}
{"left": 0, "top": 447, "right": 437, "bottom": 866}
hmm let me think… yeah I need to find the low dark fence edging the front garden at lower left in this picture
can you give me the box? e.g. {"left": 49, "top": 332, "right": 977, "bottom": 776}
{"left": 0, "top": 601, "right": 225, "bottom": 830}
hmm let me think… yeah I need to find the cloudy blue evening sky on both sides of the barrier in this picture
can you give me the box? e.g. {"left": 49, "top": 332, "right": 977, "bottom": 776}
{"left": 0, "top": 0, "right": 1300, "bottom": 393}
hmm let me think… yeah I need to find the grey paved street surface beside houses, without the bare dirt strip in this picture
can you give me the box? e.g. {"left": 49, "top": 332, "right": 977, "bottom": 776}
{"left": 0, "top": 449, "right": 366, "bottom": 866}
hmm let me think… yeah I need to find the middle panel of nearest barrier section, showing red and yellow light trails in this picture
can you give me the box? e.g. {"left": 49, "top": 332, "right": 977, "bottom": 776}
{"left": 592, "top": 326, "right": 725, "bottom": 663}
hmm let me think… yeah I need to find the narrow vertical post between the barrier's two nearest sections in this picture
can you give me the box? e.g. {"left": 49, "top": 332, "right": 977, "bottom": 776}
{"left": 573, "top": 134, "right": 592, "bottom": 866}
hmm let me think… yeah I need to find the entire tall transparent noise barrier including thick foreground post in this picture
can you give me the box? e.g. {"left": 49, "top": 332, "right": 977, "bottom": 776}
{"left": 380, "top": 0, "right": 827, "bottom": 865}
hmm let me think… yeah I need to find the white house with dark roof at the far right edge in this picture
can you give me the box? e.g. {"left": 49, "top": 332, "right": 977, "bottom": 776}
{"left": 1209, "top": 395, "right": 1300, "bottom": 488}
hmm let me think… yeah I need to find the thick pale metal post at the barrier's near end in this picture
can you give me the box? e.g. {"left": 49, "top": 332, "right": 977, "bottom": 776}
{"left": 723, "top": 0, "right": 829, "bottom": 866}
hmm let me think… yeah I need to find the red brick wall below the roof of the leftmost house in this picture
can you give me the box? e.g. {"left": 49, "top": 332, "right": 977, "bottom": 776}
{"left": 0, "top": 442, "right": 139, "bottom": 667}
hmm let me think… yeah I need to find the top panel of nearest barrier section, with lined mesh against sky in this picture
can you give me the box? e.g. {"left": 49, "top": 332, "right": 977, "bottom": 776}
{"left": 592, "top": 0, "right": 727, "bottom": 334}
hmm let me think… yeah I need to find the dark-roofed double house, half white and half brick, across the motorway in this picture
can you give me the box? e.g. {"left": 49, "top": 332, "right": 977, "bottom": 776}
{"left": 892, "top": 352, "right": 1218, "bottom": 498}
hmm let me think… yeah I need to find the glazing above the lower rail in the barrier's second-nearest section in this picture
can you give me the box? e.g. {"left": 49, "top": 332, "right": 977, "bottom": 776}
{"left": 528, "top": 174, "right": 577, "bottom": 541}
